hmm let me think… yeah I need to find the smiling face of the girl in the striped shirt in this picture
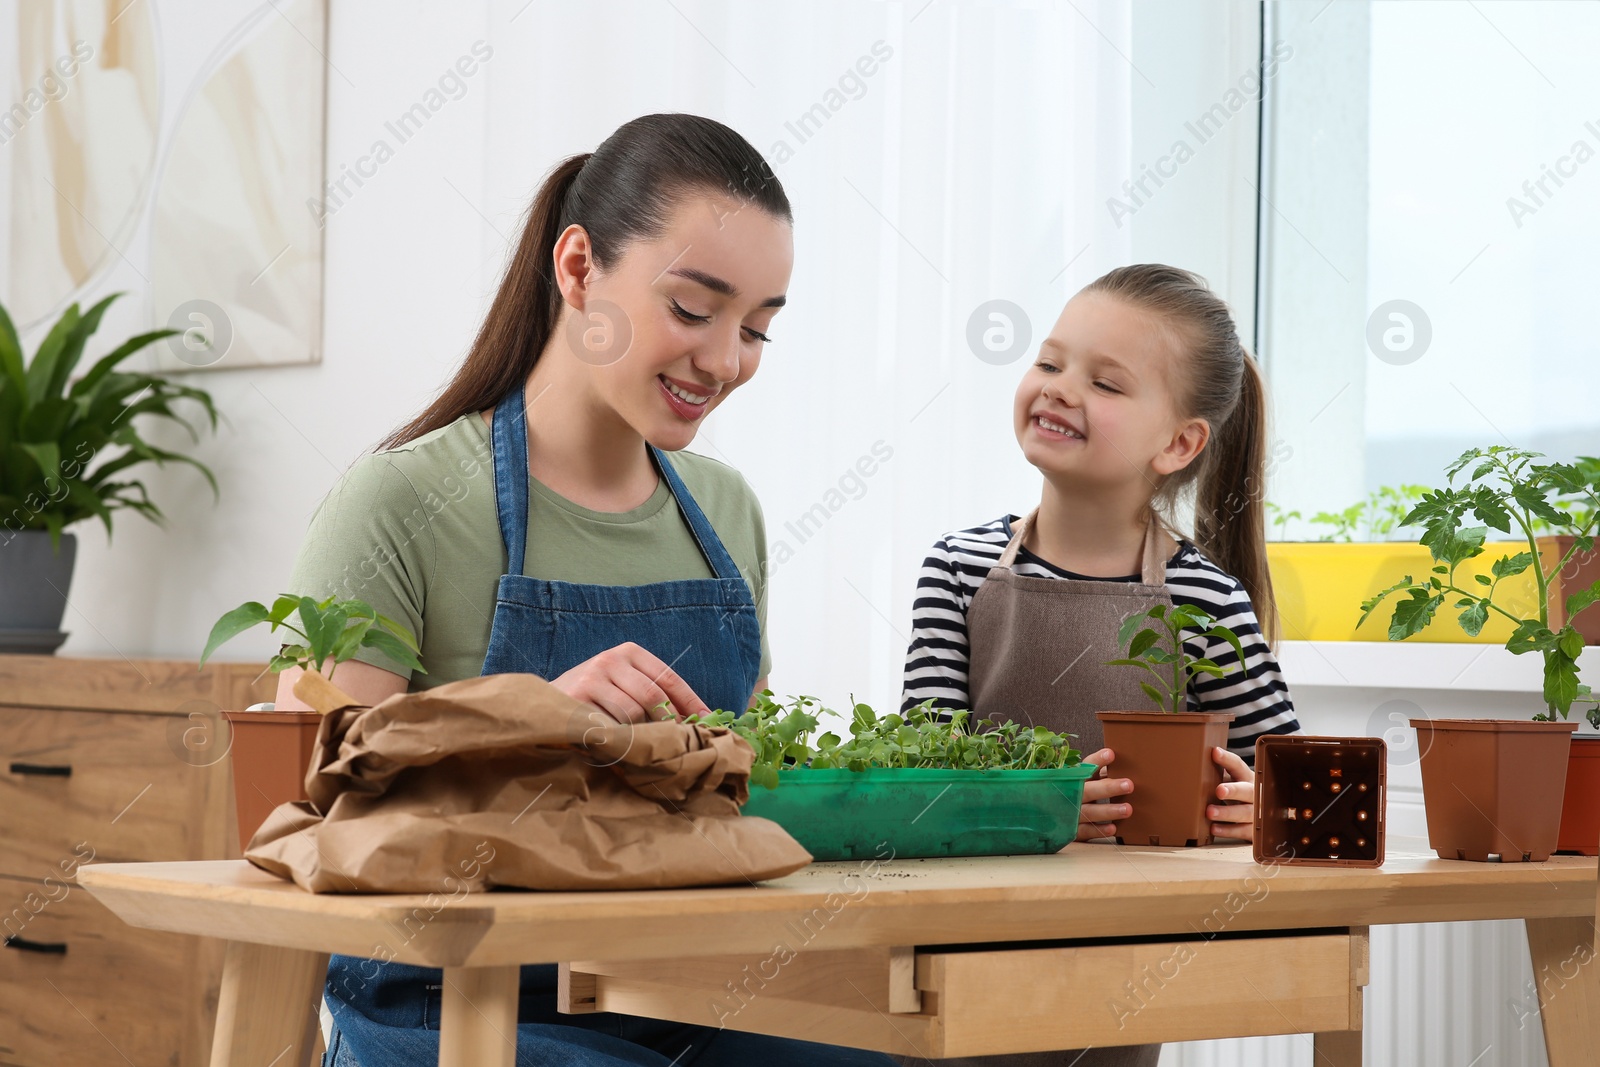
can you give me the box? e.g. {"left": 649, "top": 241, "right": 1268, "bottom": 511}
{"left": 1014, "top": 291, "right": 1211, "bottom": 496}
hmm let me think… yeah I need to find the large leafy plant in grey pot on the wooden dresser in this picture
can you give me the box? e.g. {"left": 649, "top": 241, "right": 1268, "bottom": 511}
{"left": 0, "top": 293, "right": 216, "bottom": 654}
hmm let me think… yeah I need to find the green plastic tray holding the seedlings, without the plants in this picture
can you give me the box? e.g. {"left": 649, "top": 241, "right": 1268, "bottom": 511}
{"left": 744, "top": 763, "right": 1096, "bottom": 859}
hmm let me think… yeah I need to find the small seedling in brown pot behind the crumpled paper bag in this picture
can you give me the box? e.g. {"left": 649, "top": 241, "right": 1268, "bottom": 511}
{"left": 200, "top": 593, "right": 427, "bottom": 848}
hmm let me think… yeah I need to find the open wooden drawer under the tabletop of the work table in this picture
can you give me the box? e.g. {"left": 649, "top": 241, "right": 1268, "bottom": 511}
{"left": 562, "top": 929, "right": 1366, "bottom": 1059}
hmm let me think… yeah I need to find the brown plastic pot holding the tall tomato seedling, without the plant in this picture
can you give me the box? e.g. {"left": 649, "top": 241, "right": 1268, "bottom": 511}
{"left": 1411, "top": 718, "right": 1578, "bottom": 862}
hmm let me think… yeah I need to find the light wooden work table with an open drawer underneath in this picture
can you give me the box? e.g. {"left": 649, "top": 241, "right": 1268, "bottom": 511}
{"left": 78, "top": 838, "right": 1600, "bottom": 1067}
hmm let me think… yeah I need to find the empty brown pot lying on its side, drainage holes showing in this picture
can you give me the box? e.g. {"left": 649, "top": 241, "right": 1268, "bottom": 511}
{"left": 1254, "top": 734, "right": 1389, "bottom": 867}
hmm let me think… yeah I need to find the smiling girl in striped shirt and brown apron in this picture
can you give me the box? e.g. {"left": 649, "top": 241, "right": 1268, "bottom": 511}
{"left": 904, "top": 264, "right": 1299, "bottom": 840}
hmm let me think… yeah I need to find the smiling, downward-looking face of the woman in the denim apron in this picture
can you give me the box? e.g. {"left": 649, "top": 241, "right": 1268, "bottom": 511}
{"left": 555, "top": 192, "right": 794, "bottom": 451}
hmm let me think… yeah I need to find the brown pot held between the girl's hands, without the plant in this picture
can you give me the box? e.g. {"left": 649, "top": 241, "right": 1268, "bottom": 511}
{"left": 1096, "top": 712, "right": 1234, "bottom": 846}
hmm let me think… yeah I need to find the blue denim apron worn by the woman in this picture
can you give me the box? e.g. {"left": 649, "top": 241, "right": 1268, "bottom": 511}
{"left": 323, "top": 386, "right": 891, "bottom": 1067}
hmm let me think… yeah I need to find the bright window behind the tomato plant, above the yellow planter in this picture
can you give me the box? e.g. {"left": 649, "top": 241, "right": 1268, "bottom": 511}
{"left": 1258, "top": 2, "right": 1600, "bottom": 536}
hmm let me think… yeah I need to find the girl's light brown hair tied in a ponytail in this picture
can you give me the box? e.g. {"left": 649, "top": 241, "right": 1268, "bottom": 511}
{"left": 1083, "top": 262, "right": 1278, "bottom": 641}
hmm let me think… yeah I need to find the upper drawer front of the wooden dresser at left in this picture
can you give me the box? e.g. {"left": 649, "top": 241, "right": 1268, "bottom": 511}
{"left": 0, "top": 707, "right": 229, "bottom": 878}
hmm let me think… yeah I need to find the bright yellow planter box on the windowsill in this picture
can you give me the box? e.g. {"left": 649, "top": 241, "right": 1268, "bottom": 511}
{"left": 1267, "top": 541, "right": 1538, "bottom": 645}
